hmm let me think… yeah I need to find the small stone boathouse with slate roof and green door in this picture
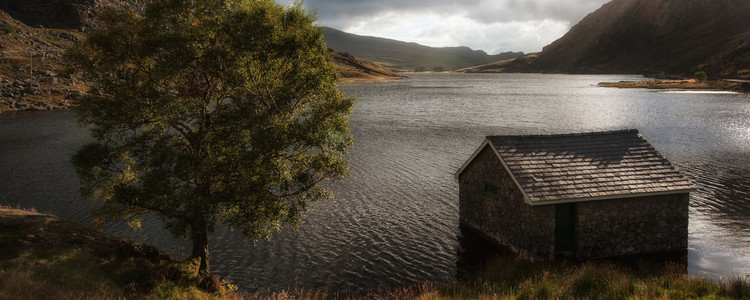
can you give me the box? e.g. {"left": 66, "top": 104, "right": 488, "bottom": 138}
{"left": 455, "top": 130, "right": 696, "bottom": 261}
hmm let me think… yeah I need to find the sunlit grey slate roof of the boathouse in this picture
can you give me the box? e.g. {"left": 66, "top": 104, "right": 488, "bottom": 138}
{"left": 487, "top": 129, "right": 696, "bottom": 204}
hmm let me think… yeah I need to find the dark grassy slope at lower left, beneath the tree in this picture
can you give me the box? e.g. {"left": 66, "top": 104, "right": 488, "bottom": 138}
{"left": 0, "top": 208, "right": 239, "bottom": 299}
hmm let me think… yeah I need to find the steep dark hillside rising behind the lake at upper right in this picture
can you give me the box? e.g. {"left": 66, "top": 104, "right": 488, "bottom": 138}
{"left": 464, "top": 0, "right": 750, "bottom": 77}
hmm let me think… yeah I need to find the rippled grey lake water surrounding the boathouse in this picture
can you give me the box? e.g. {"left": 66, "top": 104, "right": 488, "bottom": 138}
{"left": 0, "top": 74, "right": 750, "bottom": 293}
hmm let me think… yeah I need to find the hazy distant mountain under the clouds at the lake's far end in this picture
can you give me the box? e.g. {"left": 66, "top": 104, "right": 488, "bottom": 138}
{"left": 325, "top": 27, "right": 523, "bottom": 71}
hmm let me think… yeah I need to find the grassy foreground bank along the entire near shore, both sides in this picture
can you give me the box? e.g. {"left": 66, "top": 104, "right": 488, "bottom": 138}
{"left": 0, "top": 208, "right": 750, "bottom": 300}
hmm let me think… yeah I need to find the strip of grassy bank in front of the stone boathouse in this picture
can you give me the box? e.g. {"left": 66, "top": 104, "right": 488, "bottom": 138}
{"left": 417, "top": 257, "right": 750, "bottom": 299}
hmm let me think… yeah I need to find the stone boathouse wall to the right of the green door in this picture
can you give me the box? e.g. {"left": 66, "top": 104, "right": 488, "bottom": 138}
{"left": 576, "top": 193, "right": 689, "bottom": 257}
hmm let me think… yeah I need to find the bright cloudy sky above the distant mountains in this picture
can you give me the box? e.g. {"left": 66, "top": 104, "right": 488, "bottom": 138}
{"left": 276, "top": 0, "right": 610, "bottom": 54}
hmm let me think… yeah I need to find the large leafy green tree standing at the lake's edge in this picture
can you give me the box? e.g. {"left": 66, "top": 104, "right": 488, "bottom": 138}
{"left": 66, "top": 0, "right": 354, "bottom": 272}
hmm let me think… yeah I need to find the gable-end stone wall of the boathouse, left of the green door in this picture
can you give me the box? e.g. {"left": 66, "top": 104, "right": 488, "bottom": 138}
{"left": 459, "top": 147, "right": 555, "bottom": 261}
